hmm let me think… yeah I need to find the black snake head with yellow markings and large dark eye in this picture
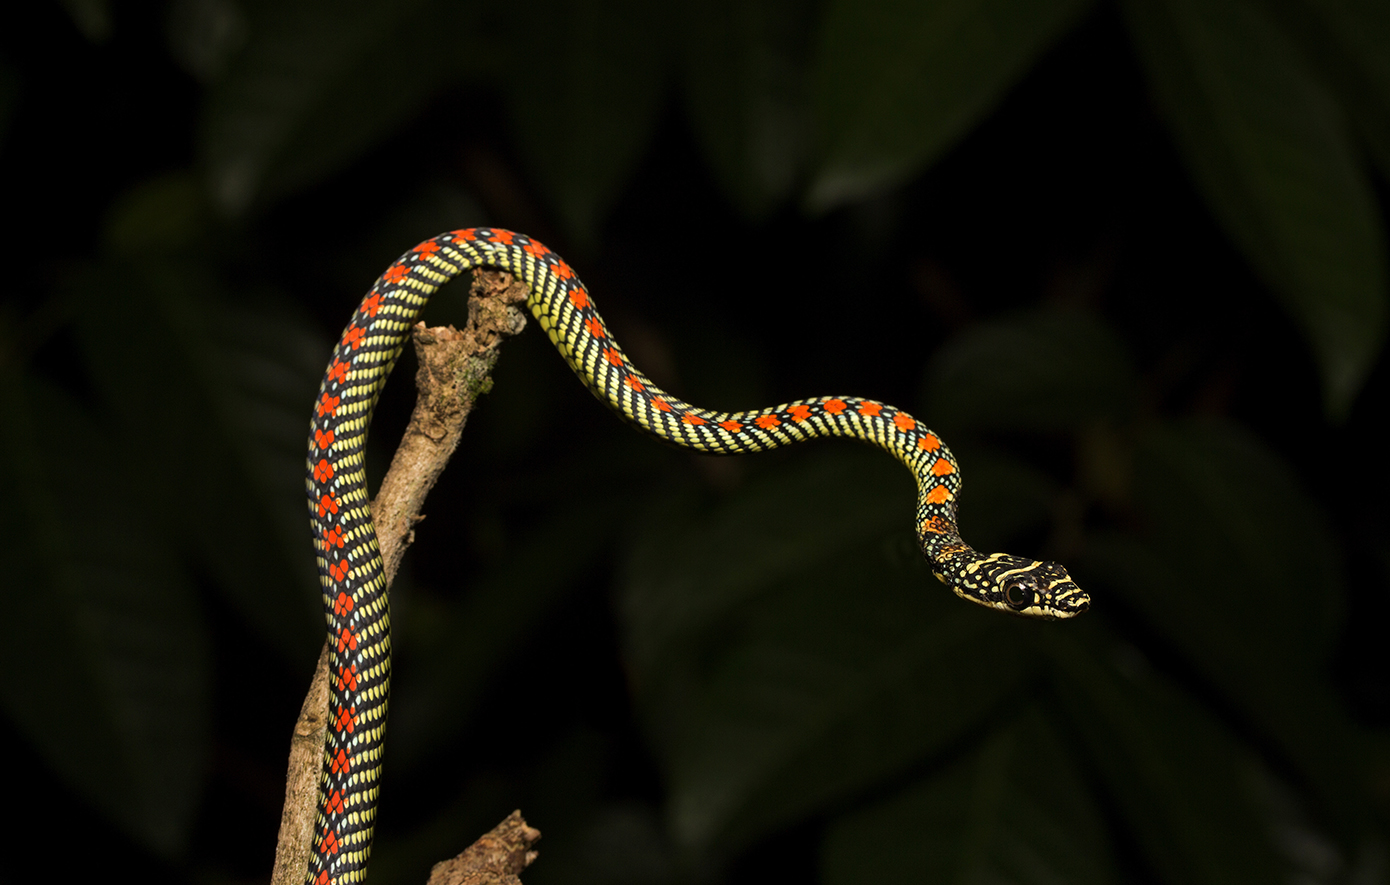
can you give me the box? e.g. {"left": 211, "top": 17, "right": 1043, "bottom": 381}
{"left": 937, "top": 553, "right": 1091, "bottom": 620}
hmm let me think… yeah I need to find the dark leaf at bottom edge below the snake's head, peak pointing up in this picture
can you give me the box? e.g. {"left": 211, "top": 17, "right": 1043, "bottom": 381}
{"left": 821, "top": 707, "right": 1116, "bottom": 885}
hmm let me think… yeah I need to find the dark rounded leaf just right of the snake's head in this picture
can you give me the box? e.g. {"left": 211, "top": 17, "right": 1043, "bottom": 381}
{"left": 1098, "top": 422, "right": 1341, "bottom": 661}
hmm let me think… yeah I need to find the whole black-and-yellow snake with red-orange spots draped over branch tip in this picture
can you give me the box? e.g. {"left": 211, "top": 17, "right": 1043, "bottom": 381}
{"left": 304, "top": 228, "right": 1090, "bottom": 885}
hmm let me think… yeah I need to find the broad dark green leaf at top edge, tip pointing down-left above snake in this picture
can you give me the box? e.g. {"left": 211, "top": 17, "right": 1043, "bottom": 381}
{"left": 806, "top": 0, "right": 1091, "bottom": 211}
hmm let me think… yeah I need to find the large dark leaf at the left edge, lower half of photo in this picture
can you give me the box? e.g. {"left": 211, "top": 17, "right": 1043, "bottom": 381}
{"left": 0, "top": 375, "right": 214, "bottom": 854}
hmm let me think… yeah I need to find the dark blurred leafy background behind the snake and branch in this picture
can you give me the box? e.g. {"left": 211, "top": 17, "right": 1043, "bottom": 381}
{"left": 0, "top": 0, "right": 1390, "bottom": 885}
